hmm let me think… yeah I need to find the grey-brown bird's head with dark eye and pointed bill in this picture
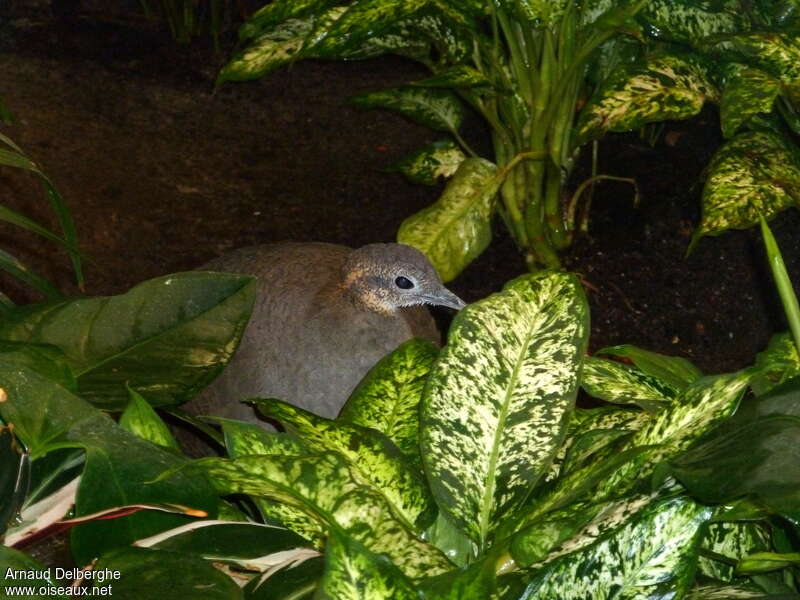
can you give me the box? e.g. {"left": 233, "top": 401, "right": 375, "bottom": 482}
{"left": 342, "top": 244, "right": 466, "bottom": 314}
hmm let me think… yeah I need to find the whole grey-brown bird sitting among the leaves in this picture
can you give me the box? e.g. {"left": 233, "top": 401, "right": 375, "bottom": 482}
{"left": 185, "top": 242, "right": 465, "bottom": 428}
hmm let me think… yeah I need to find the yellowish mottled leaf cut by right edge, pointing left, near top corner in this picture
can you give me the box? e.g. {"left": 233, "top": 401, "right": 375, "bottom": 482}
{"left": 715, "top": 31, "right": 800, "bottom": 100}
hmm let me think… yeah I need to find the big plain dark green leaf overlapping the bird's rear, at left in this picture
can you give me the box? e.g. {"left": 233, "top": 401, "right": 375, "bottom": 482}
{"left": 0, "top": 272, "right": 255, "bottom": 408}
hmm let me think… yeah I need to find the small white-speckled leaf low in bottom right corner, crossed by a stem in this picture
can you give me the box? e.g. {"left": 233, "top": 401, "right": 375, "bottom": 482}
{"left": 697, "top": 522, "right": 771, "bottom": 582}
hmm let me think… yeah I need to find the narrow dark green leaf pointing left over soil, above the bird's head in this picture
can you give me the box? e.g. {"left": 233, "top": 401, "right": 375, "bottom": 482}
{"left": 352, "top": 87, "right": 465, "bottom": 132}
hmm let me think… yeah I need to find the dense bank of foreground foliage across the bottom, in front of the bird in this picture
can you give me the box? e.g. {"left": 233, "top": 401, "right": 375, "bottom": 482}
{"left": 0, "top": 271, "right": 800, "bottom": 600}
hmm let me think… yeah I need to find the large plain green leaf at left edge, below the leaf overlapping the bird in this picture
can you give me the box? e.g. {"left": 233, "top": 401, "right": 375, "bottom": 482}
{"left": 0, "top": 365, "right": 216, "bottom": 564}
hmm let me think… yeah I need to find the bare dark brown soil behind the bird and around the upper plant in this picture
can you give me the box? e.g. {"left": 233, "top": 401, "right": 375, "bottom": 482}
{"left": 0, "top": 9, "right": 800, "bottom": 380}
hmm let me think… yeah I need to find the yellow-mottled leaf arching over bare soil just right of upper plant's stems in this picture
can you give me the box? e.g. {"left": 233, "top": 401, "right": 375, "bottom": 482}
{"left": 577, "top": 54, "right": 719, "bottom": 143}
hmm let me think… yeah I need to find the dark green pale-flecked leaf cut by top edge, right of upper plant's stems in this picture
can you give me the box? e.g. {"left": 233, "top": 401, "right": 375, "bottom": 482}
{"left": 637, "top": 0, "right": 750, "bottom": 44}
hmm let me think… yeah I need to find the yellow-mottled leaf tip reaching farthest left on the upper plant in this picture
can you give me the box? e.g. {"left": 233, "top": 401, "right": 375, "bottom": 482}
{"left": 222, "top": 15, "right": 314, "bottom": 83}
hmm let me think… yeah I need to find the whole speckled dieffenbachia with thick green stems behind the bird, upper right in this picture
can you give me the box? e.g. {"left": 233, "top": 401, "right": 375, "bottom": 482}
{"left": 219, "top": 0, "right": 800, "bottom": 280}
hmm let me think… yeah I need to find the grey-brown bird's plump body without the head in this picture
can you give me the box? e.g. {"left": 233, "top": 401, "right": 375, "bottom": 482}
{"left": 189, "top": 243, "right": 439, "bottom": 420}
